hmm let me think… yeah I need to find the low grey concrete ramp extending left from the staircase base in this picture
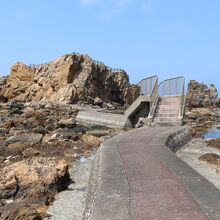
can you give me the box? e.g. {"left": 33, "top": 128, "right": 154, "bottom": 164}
{"left": 76, "top": 111, "right": 132, "bottom": 128}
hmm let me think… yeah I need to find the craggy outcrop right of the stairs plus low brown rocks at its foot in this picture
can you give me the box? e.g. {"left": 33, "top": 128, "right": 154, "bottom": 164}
{"left": 185, "top": 80, "right": 220, "bottom": 137}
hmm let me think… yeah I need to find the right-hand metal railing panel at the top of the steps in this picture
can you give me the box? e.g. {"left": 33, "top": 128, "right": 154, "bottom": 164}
{"left": 158, "top": 76, "right": 185, "bottom": 96}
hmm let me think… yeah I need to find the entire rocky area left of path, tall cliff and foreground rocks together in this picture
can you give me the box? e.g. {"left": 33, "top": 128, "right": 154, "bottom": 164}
{"left": 0, "top": 53, "right": 140, "bottom": 220}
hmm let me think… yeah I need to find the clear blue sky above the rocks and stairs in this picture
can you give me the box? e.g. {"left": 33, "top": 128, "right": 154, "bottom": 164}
{"left": 0, "top": 0, "right": 220, "bottom": 91}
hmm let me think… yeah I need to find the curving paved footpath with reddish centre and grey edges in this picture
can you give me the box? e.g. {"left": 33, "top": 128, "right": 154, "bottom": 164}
{"left": 85, "top": 127, "right": 220, "bottom": 220}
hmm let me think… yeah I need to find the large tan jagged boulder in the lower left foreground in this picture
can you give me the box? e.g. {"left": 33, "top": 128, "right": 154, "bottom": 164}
{"left": 0, "top": 157, "right": 69, "bottom": 199}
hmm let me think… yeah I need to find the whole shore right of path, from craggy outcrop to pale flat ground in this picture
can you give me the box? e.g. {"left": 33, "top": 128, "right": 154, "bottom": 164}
{"left": 176, "top": 80, "right": 220, "bottom": 189}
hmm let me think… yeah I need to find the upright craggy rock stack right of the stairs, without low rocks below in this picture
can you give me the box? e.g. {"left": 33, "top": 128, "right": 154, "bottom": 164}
{"left": 187, "top": 80, "right": 218, "bottom": 108}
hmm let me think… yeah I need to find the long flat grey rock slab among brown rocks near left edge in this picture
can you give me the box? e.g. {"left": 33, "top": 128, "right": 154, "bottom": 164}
{"left": 6, "top": 134, "right": 43, "bottom": 144}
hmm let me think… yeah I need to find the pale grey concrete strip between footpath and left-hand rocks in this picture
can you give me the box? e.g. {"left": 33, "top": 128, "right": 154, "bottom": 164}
{"left": 45, "top": 157, "right": 93, "bottom": 220}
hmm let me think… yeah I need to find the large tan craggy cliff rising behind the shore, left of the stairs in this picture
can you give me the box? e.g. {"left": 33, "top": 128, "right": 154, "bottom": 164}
{"left": 0, "top": 54, "right": 139, "bottom": 104}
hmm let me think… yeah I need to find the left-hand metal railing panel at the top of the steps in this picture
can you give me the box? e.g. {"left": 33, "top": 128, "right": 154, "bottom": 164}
{"left": 138, "top": 76, "right": 158, "bottom": 96}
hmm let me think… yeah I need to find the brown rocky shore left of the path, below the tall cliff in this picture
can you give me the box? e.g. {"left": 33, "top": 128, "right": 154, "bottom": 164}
{"left": 0, "top": 101, "right": 125, "bottom": 220}
